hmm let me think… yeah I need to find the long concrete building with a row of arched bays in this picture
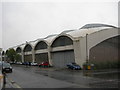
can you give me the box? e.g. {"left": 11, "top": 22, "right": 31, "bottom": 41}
{"left": 2, "top": 24, "right": 120, "bottom": 68}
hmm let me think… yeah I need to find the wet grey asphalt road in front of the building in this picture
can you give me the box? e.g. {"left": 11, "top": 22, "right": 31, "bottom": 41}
{"left": 6, "top": 65, "right": 119, "bottom": 88}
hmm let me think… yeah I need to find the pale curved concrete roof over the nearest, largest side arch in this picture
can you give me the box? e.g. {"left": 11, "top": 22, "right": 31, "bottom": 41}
{"left": 51, "top": 24, "right": 118, "bottom": 45}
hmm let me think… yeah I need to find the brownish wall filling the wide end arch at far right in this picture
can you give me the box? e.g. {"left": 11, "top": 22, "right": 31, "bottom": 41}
{"left": 89, "top": 35, "right": 120, "bottom": 63}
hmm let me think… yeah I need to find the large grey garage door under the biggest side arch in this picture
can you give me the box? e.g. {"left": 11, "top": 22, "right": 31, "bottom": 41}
{"left": 52, "top": 50, "right": 75, "bottom": 68}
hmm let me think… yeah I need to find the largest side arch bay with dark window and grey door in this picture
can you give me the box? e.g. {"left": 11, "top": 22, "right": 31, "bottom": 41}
{"left": 51, "top": 34, "right": 75, "bottom": 68}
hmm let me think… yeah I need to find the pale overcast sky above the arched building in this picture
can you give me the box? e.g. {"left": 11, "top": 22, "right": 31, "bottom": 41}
{"left": 0, "top": 0, "right": 118, "bottom": 49}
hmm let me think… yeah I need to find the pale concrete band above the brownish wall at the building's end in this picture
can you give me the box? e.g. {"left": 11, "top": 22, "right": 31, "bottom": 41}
{"left": 87, "top": 28, "right": 119, "bottom": 56}
